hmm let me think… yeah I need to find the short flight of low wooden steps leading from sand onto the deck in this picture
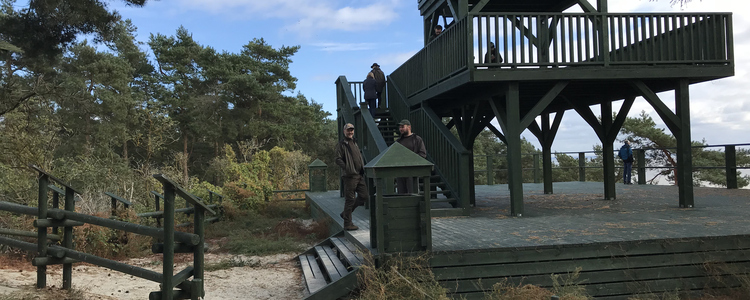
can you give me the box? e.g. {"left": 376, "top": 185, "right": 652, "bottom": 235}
{"left": 298, "top": 231, "right": 364, "bottom": 300}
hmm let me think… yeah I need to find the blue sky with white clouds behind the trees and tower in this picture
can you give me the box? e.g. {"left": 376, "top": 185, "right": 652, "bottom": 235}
{"left": 110, "top": 0, "right": 750, "bottom": 152}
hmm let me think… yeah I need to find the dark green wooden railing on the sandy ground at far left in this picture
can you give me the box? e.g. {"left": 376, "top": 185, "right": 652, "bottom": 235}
{"left": 0, "top": 166, "right": 215, "bottom": 300}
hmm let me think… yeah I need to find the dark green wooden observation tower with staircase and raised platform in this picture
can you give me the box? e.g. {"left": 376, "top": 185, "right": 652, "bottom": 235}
{"left": 337, "top": 0, "right": 734, "bottom": 216}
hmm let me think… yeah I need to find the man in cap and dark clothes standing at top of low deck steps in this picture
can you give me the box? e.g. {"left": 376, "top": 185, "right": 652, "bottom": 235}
{"left": 336, "top": 123, "right": 370, "bottom": 230}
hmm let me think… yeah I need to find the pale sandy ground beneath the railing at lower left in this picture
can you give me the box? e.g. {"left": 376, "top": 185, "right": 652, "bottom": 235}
{"left": 0, "top": 253, "right": 303, "bottom": 300}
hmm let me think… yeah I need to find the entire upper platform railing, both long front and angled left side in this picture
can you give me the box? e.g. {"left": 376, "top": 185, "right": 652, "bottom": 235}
{"left": 390, "top": 13, "right": 734, "bottom": 97}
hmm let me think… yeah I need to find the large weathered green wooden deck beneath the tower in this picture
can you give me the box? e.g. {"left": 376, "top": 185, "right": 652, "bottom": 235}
{"left": 308, "top": 182, "right": 750, "bottom": 299}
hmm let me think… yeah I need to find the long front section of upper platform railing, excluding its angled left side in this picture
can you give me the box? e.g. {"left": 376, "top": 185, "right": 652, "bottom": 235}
{"left": 471, "top": 13, "right": 733, "bottom": 67}
